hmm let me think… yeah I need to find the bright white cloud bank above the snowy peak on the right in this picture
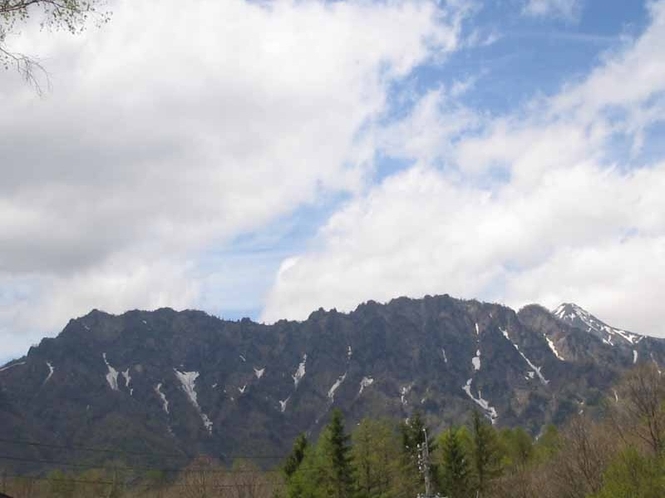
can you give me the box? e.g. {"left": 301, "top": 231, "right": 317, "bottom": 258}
{"left": 264, "top": 2, "right": 665, "bottom": 336}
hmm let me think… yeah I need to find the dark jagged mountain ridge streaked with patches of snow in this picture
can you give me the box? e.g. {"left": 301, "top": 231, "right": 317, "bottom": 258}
{"left": 0, "top": 296, "right": 665, "bottom": 470}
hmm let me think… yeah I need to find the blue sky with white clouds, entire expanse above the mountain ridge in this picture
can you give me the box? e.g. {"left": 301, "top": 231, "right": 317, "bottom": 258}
{"left": 0, "top": 0, "right": 665, "bottom": 360}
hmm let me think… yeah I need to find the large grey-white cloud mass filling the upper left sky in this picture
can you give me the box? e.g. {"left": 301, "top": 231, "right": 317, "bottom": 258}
{"left": 0, "top": 0, "right": 466, "bottom": 354}
